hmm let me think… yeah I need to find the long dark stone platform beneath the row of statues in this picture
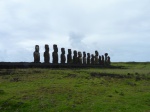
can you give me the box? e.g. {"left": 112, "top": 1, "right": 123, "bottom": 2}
{"left": 0, "top": 62, "right": 118, "bottom": 69}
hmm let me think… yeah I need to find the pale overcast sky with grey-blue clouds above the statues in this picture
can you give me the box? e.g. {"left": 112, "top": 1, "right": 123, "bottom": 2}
{"left": 0, "top": 0, "right": 150, "bottom": 62}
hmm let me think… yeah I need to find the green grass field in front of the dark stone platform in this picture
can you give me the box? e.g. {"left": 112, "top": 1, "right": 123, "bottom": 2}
{"left": 0, "top": 62, "right": 150, "bottom": 112}
